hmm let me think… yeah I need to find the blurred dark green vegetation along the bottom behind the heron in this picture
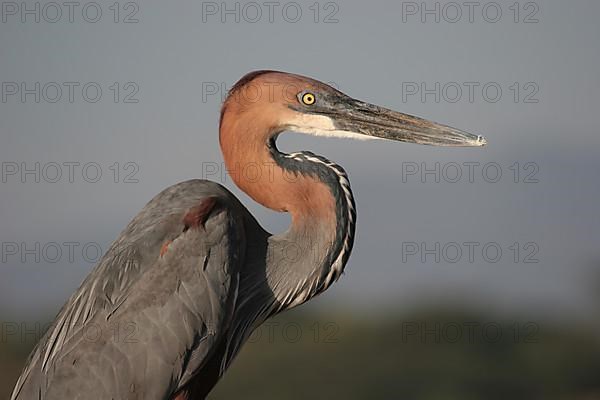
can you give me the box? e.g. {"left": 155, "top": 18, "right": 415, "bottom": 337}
{"left": 0, "top": 309, "right": 600, "bottom": 400}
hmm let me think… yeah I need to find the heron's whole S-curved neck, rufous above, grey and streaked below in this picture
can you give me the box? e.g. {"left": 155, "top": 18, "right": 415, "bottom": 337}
{"left": 221, "top": 119, "right": 356, "bottom": 309}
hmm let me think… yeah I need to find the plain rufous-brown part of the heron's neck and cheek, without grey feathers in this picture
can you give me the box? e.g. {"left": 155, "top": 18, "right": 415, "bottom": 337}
{"left": 219, "top": 91, "right": 335, "bottom": 226}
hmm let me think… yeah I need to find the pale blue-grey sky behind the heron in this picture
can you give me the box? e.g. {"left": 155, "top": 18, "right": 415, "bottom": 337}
{"left": 0, "top": 0, "right": 600, "bottom": 328}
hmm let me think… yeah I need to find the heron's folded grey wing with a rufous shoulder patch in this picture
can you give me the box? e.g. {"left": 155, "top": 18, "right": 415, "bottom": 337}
{"left": 11, "top": 180, "right": 245, "bottom": 400}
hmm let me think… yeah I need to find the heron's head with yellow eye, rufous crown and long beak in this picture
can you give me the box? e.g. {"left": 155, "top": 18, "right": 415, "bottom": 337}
{"left": 221, "top": 71, "right": 486, "bottom": 146}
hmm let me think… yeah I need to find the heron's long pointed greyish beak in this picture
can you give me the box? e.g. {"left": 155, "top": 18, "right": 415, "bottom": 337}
{"left": 330, "top": 98, "right": 487, "bottom": 146}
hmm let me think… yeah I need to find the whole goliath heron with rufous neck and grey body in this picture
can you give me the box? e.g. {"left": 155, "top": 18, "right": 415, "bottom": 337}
{"left": 11, "top": 71, "right": 486, "bottom": 400}
